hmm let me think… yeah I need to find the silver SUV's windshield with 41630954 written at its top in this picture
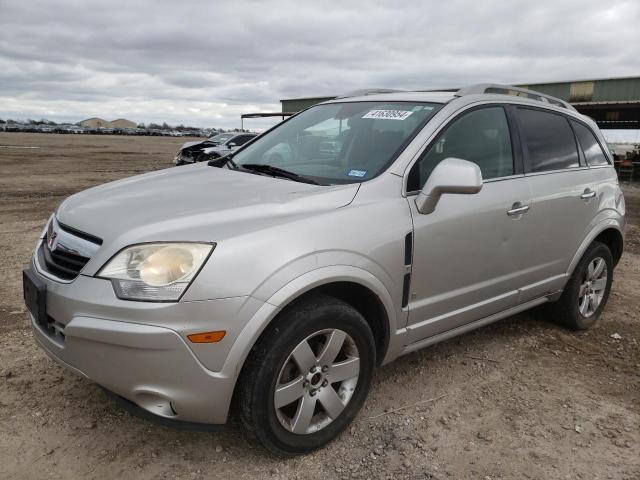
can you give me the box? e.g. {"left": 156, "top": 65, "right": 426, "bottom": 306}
{"left": 233, "top": 102, "right": 440, "bottom": 184}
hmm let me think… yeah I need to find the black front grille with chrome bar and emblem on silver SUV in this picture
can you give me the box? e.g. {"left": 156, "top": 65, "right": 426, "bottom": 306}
{"left": 38, "top": 218, "right": 102, "bottom": 281}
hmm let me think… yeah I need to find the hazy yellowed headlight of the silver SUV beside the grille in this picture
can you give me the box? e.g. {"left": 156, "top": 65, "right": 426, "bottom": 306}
{"left": 98, "top": 243, "right": 215, "bottom": 302}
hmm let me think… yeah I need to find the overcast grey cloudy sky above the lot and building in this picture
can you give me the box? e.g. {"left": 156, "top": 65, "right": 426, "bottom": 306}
{"left": 0, "top": 0, "right": 640, "bottom": 135}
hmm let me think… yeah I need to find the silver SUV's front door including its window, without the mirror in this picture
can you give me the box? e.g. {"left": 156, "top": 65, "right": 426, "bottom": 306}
{"left": 407, "top": 105, "right": 531, "bottom": 343}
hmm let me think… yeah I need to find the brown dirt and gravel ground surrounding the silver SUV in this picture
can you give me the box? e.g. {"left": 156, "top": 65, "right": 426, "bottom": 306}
{"left": 0, "top": 133, "right": 640, "bottom": 480}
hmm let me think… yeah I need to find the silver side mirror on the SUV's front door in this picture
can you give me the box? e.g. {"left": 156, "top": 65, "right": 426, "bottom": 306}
{"left": 416, "top": 157, "right": 482, "bottom": 214}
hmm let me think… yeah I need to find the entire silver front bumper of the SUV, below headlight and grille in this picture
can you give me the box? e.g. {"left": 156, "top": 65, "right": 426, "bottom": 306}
{"left": 26, "top": 267, "right": 264, "bottom": 423}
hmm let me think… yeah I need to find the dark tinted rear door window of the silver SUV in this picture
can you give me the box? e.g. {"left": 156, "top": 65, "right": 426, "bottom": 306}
{"left": 518, "top": 107, "right": 580, "bottom": 172}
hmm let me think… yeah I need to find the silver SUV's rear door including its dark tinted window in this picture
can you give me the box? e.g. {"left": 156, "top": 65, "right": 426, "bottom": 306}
{"left": 516, "top": 106, "right": 598, "bottom": 303}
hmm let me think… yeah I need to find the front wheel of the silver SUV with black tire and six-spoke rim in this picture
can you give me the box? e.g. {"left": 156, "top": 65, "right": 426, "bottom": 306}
{"left": 238, "top": 295, "right": 376, "bottom": 456}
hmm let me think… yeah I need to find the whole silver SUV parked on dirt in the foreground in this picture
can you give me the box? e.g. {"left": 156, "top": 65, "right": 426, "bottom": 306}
{"left": 24, "top": 85, "right": 625, "bottom": 455}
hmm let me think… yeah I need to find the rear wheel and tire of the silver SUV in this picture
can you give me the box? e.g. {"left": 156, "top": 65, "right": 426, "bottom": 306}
{"left": 549, "top": 242, "right": 613, "bottom": 330}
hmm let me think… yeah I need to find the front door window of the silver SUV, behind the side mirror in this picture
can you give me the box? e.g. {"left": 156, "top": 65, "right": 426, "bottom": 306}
{"left": 407, "top": 107, "right": 514, "bottom": 191}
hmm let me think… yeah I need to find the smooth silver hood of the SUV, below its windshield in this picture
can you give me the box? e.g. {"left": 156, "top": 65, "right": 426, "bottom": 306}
{"left": 56, "top": 163, "right": 358, "bottom": 250}
